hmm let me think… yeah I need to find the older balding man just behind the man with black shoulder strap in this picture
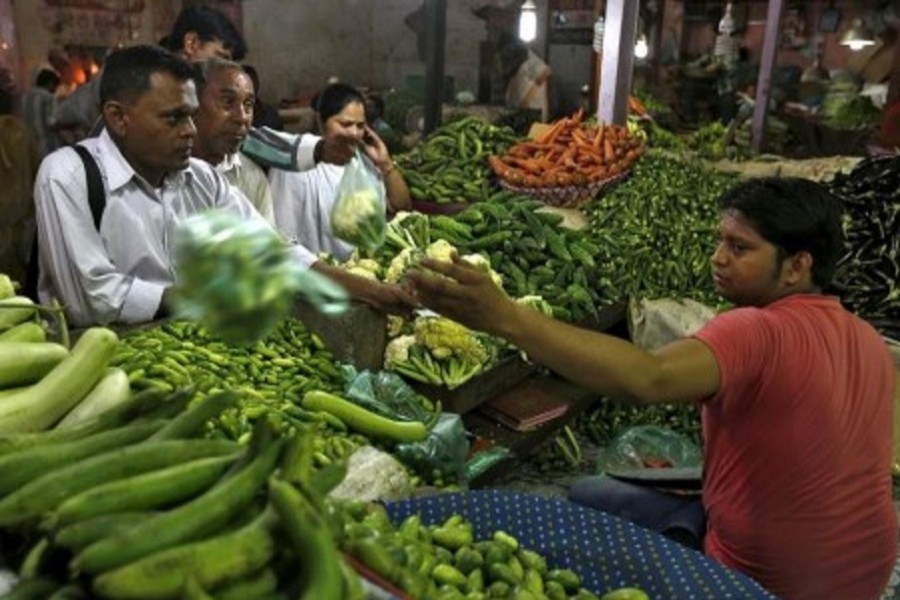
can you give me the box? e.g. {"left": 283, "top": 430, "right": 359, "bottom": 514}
{"left": 192, "top": 58, "right": 275, "bottom": 226}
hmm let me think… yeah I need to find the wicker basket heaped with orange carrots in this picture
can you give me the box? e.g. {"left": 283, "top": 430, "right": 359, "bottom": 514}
{"left": 489, "top": 111, "right": 643, "bottom": 208}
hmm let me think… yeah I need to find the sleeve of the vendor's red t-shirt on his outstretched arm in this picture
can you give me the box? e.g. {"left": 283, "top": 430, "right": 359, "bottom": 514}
{"left": 694, "top": 308, "right": 772, "bottom": 401}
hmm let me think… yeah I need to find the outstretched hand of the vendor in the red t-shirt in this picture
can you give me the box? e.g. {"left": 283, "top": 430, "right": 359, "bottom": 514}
{"left": 407, "top": 253, "right": 518, "bottom": 337}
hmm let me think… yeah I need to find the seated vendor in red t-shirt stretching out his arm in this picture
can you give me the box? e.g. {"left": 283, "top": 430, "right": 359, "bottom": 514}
{"left": 409, "top": 178, "right": 897, "bottom": 600}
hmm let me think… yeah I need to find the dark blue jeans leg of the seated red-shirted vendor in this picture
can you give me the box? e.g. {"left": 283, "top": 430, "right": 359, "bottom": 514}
{"left": 569, "top": 475, "right": 706, "bottom": 552}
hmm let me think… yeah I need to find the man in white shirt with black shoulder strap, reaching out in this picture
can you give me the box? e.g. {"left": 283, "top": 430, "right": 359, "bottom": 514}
{"left": 35, "top": 46, "right": 413, "bottom": 326}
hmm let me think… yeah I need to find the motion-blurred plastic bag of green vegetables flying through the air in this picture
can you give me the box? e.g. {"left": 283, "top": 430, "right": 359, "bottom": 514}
{"left": 174, "top": 210, "right": 349, "bottom": 344}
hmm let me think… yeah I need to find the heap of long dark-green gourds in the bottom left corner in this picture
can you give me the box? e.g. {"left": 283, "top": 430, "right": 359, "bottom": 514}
{"left": 0, "top": 424, "right": 363, "bottom": 600}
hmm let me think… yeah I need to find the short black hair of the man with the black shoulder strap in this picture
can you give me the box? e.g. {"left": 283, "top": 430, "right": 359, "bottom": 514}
{"left": 100, "top": 45, "right": 194, "bottom": 105}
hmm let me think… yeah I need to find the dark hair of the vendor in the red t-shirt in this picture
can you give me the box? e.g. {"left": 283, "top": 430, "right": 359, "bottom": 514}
{"left": 719, "top": 177, "right": 844, "bottom": 289}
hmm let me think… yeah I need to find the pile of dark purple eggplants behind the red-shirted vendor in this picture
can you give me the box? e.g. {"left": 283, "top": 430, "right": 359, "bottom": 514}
{"left": 830, "top": 156, "right": 900, "bottom": 339}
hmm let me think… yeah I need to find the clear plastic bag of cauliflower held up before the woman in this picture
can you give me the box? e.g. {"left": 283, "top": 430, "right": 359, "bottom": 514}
{"left": 331, "top": 149, "right": 386, "bottom": 250}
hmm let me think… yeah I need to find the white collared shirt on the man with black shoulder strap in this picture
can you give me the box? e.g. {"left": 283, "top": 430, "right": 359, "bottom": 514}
{"left": 34, "top": 130, "right": 316, "bottom": 326}
